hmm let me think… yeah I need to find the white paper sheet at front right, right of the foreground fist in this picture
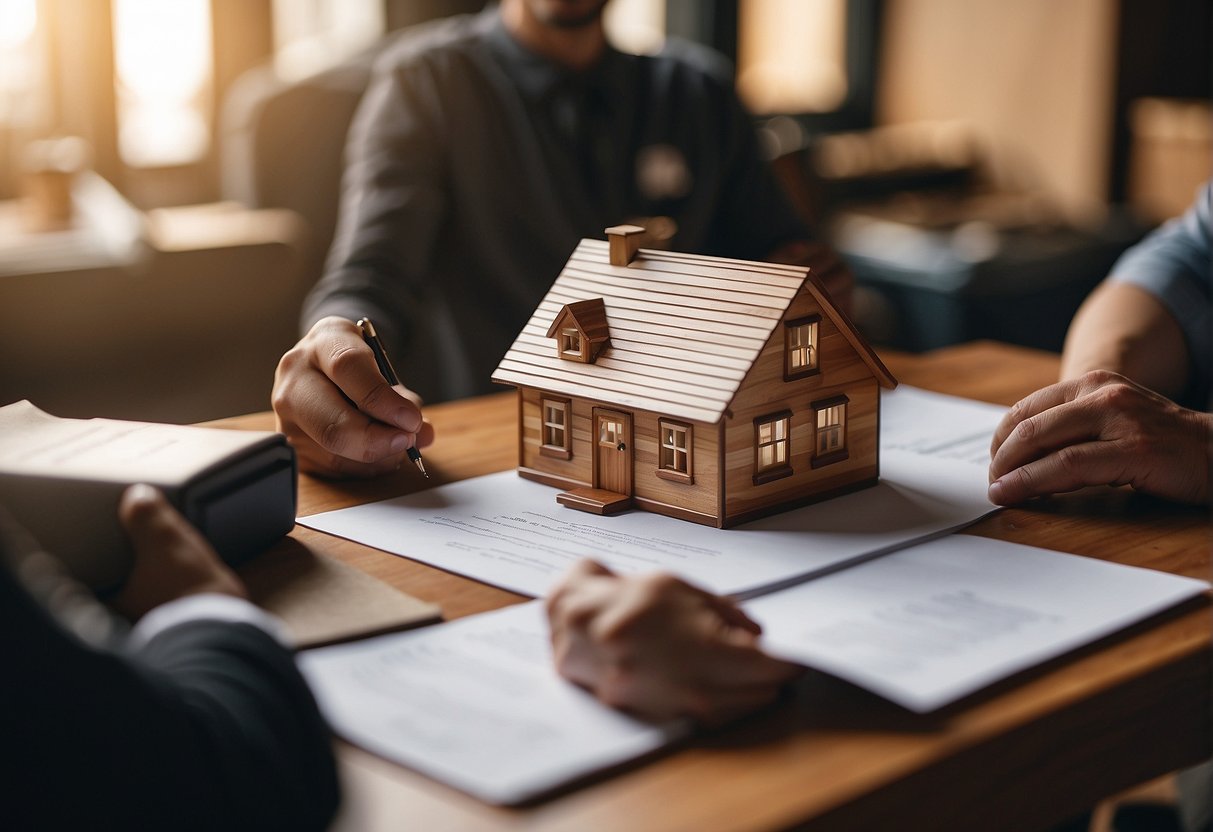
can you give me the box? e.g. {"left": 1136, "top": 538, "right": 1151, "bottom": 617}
{"left": 745, "top": 535, "right": 1208, "bottom": 712}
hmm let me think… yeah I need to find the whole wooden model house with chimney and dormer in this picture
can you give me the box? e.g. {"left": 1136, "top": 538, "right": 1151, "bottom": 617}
{"left": 492, "top": 226, "right": 896, "bottom": 528}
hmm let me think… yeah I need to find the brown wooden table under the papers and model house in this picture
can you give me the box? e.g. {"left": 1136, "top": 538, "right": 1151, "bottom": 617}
{"left": 218, "top": 342, "right": 1213, "bottom": 832}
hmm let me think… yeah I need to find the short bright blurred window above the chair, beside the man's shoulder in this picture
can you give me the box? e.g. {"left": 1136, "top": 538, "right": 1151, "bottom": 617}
{"left": 273, "top": 0, "right": 386, "bottom": 81}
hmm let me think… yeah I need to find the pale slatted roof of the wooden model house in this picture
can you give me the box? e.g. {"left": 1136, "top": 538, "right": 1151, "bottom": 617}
{"left": 492, "top": 240, "right": 894, "bottom": 423}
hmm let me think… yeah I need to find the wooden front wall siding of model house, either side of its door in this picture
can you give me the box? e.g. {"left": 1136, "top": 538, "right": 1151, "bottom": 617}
{"left": 519, "top": 388, "right": 719, "bottom": 518}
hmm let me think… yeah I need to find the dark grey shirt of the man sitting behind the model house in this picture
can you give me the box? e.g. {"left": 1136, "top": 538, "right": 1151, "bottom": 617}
{"left": 302, "top": 8, "right": 808, "bottom": 401}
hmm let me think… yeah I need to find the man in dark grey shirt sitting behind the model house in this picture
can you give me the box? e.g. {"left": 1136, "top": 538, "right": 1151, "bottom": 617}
{"left": 273, "top": 0, "right": 850, "bottom": 477}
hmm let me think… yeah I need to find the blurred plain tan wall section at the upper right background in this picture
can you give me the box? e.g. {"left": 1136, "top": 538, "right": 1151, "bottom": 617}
{"left": 877, "top": 0, "right": 1117, "bottom": 215}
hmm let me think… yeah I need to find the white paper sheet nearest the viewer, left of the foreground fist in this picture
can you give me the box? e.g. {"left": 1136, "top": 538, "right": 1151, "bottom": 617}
{"left": 298, "top": 602, "right": 690, "bottom": 804}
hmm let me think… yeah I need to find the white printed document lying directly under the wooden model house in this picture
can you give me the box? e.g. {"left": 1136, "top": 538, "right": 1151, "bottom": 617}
{"left": 300, "top": 388, "right": 1004, "bottom": 597}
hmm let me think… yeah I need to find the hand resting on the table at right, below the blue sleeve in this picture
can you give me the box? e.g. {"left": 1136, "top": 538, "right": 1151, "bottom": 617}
{"left": 990, "top": 370, "right": 1213, "bottom": 506}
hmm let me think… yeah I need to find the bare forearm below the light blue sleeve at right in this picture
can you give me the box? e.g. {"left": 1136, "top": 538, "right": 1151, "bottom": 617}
{"left": 1061, "top": 283, "right": 1191, "bottom": 399}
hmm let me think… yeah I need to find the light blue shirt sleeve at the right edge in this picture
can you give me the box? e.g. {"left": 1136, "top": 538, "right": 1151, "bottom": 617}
{"left": 1109, "top": 181, "right": 1213, "bottom": 392}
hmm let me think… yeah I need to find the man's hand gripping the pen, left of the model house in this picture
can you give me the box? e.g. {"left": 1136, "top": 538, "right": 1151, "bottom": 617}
{"left": 272, "top": 317, "right": 434, "bottom": 477}
